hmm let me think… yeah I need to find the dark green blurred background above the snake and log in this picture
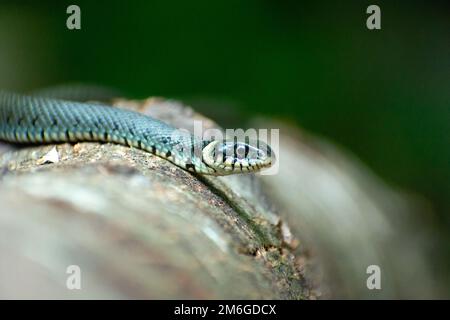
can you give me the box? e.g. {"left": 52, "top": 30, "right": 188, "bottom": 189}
{"left": 0, "top": 0, "right": 450, "bottom": 226}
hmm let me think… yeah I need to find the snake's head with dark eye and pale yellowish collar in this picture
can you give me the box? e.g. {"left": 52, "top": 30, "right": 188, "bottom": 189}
{"left": 202, "top": 140, "right": 275, "bottom": 175}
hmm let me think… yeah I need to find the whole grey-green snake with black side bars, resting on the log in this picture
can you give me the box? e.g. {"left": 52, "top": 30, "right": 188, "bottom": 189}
{"left": 0, "top": 90, "right": 275, "bottom": 176}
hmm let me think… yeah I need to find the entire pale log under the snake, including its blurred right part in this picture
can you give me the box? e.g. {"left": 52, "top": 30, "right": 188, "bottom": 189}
{"left": 0, "top": 98, "right": 442, "bottom": 299}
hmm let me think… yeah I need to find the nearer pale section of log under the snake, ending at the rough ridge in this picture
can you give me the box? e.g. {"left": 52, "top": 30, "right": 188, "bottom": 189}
{"left": 0, "top": 99, "right": 314, "bottom": 299}
